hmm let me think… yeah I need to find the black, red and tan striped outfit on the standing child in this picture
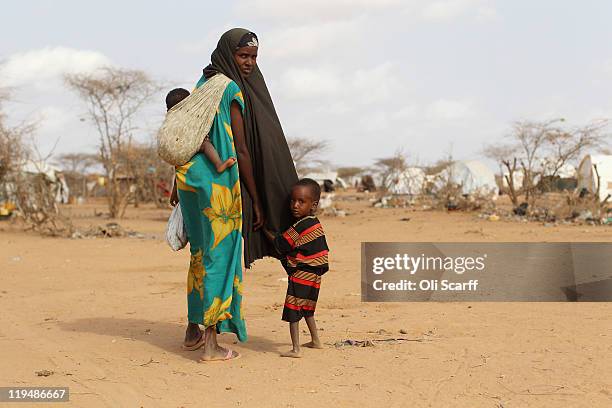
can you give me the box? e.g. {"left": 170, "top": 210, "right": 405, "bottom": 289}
{"left": 274, "top": 216, "right": 329, "bottom": 322}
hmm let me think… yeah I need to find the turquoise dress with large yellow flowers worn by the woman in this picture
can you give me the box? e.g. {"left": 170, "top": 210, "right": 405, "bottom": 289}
{"left": 176, "top": 77, "right": 247, "bottom": 341}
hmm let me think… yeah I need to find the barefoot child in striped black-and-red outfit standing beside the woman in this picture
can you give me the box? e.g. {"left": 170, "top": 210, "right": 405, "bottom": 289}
{"left": 264, "top": 178, "right": 329, "bottom": 357}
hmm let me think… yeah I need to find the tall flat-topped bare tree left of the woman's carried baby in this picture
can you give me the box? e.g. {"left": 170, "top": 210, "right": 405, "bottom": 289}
{"left": 65, "top": 67, "right": 160, "bottom": 218}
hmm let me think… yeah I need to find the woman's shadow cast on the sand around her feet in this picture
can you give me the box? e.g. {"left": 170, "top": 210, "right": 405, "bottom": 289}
{"left": 58, "top": 317, "right": 281, "bottom": 360}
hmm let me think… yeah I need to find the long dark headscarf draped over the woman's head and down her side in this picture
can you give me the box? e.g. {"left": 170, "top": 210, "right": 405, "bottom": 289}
{"left": 204, "top": 28, "right": 298, "bottom": 268}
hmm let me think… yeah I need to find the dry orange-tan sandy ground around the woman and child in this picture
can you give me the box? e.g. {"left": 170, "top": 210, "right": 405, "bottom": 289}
{"left": 0, "top": 196, "right": 612, "bottom": 408}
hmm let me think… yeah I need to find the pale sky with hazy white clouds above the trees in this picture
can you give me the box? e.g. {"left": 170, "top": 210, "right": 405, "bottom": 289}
{"left": 0, "top": 0, "right": 612, "bottom": 169}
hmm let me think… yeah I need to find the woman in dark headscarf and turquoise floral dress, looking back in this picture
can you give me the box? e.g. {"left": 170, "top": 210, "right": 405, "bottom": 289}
{"left": 177, "top": 28, "right": 297, "bottom": 361}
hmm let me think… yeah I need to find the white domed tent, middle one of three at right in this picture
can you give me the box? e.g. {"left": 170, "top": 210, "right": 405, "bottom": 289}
{"left": 437, "top": 160, "right": 499, "bottom": 195}
